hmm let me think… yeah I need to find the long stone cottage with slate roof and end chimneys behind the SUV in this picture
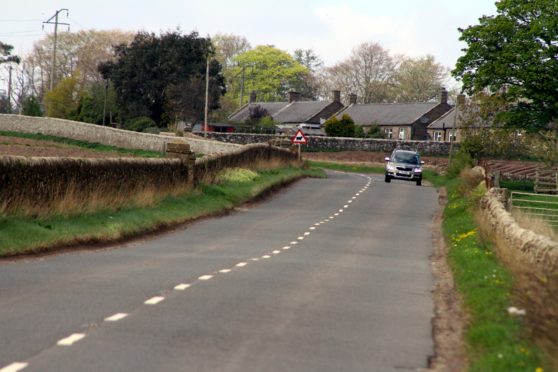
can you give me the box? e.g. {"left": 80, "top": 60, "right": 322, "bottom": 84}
{"left": 336, "top": 88, "right": 452, "bottom": 140}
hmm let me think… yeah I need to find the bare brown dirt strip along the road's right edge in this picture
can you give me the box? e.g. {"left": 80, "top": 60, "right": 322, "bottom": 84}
{"left": 429, "top": 189, "right": 468, "bottom": 371}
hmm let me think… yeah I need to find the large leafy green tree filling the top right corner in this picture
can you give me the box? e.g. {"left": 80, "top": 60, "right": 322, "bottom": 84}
{"left": 452, "top": 0, "right": 558, "bottom": 131}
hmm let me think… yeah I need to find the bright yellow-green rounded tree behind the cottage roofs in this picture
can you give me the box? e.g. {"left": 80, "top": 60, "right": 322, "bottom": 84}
{"left": 233, "top": 45, "right": 308, "bottom": 101}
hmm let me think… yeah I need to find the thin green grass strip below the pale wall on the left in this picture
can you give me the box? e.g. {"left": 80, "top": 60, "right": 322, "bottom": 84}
{"left": 0, "top": 131, "right": 165, "bottom": 158}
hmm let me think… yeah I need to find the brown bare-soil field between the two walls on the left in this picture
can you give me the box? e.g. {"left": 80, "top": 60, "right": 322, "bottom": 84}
{"left": 0, "top": 136, "right": 142, "bottom": 158}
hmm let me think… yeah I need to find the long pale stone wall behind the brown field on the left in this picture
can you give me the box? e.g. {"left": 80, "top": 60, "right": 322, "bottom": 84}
{"left": 0, "top": 114, "right": 238, "bottom": 154}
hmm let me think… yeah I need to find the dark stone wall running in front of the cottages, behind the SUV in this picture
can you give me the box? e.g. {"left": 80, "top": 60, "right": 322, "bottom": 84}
{"left": 195, "top": 132, "right": 458, "bottom": 155}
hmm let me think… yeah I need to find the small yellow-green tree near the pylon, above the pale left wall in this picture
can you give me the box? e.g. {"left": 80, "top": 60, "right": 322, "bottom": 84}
{"left": 45, "top": 75, "right": 80, "bottom": 119}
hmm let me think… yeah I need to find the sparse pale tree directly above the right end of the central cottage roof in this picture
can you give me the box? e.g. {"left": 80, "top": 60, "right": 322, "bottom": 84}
{"left": 394, "top": 55, "right": 448, "bottom": 102}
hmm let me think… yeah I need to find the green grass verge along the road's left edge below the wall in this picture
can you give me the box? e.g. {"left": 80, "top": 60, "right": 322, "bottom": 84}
{"left": 0, "top": 168, "right": 323, "bottom": 257}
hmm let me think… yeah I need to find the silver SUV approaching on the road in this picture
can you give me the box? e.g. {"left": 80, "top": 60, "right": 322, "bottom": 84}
{"left": 385, "top": 150, "right": 424, "bottom": 186}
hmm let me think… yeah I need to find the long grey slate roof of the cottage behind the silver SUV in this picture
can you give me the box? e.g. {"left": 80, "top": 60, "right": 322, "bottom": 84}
{"left": 337, "top": 102, "right": 439, "bottom": 126}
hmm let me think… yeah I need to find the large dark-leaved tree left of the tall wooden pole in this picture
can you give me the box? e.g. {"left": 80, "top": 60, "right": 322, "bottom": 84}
{"left": 99, "top": 31, "right": 226, "bottom": 126}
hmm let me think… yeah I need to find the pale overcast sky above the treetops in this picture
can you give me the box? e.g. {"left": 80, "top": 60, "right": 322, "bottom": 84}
{"left": 0, "top": 0, "right": 496, "bottom": 74}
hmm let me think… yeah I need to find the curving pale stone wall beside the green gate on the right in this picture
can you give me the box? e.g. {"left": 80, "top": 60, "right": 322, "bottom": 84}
{"left": 480, "top": 188, "right": 558, "bottom": 274}
